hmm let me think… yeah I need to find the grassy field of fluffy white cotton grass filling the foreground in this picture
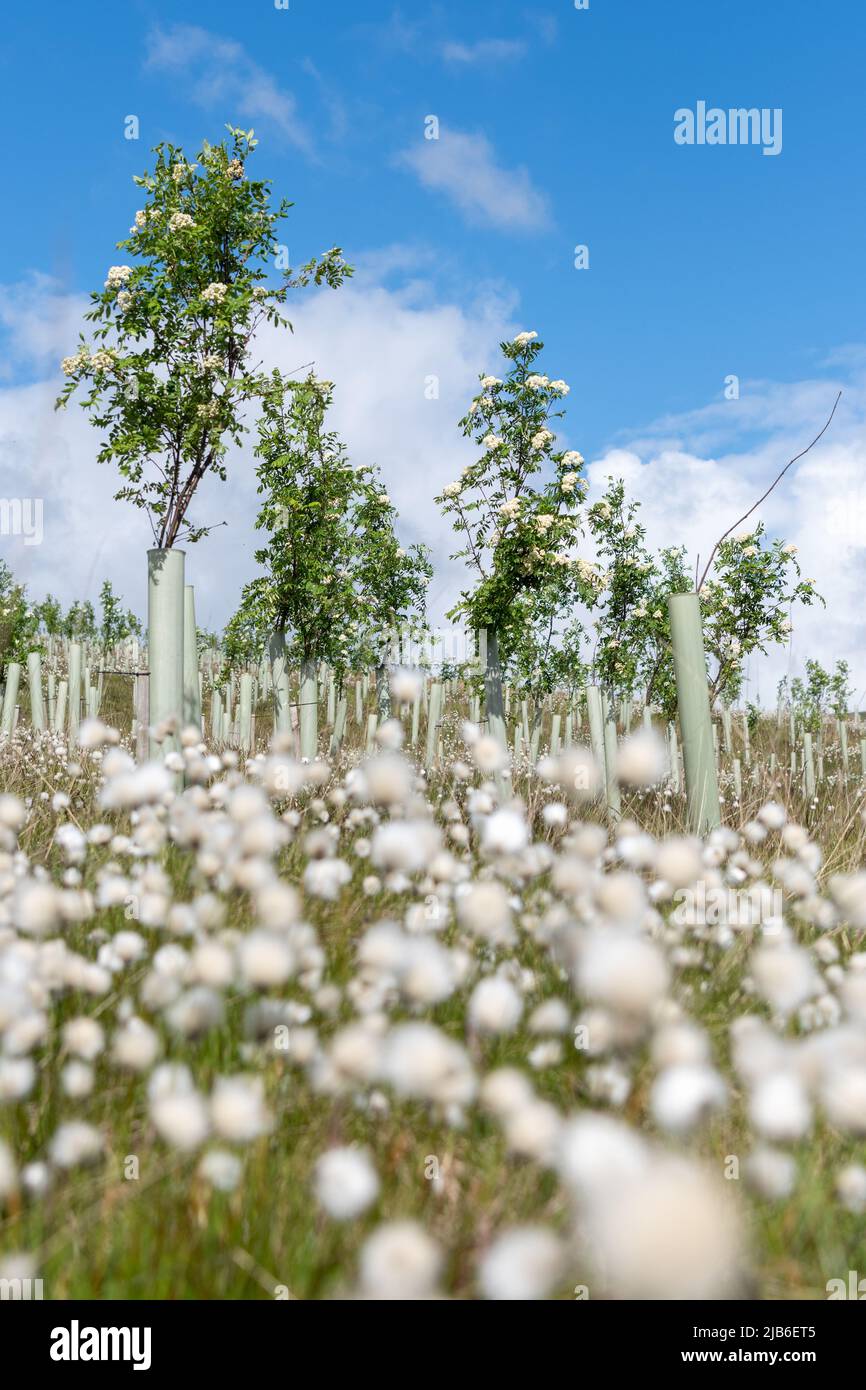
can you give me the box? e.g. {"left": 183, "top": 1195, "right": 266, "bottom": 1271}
{"left": 0, "top": 695, "right": 866, "bottom": 1300}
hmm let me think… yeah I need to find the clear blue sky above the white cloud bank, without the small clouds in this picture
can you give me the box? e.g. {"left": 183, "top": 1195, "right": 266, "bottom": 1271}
{"left": 1, "top": 0, "right": 866, "bottom": 452}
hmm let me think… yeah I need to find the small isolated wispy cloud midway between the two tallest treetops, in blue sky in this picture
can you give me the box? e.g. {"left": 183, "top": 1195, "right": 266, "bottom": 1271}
{"left": 398, "top": 128, "right": 549, "bottom": 232}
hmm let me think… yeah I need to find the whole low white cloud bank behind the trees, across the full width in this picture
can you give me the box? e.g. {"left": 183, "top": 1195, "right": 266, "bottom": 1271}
{"left": 0, "top": 268, "right": 866, "bottom": 705}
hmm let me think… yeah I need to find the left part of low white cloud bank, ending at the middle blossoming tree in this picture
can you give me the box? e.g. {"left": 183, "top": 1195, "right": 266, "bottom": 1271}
{"left": 0, "top": 268, "right": 514, "bottom": 628}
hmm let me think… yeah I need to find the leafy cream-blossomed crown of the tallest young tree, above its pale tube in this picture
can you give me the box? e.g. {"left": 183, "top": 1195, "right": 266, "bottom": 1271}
{"left": 57, "top": 126, "right": 352, "bottom": 549}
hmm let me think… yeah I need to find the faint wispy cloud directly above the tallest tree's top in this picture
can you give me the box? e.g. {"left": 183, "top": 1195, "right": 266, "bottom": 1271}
{"left": 146, "top": 24, "right": 314, "bottom": 157}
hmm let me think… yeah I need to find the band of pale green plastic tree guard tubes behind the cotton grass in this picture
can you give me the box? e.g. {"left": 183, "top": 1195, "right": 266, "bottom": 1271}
{"left": 0, "top": 581, "right": 866, "bottom": 834}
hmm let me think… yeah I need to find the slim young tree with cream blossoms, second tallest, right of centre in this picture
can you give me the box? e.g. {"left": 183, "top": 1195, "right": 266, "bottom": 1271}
{"left": 436, "top": 332, "right": 588, "bottom": 734}
